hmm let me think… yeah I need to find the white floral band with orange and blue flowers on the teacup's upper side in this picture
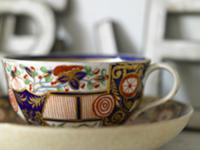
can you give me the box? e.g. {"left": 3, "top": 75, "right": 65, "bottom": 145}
{"left": 4, "top": 64, "right": 109, "bottom": 94}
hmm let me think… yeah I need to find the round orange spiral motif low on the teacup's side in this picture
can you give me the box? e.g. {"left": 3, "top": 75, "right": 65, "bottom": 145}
{"left": 93, "top": 95, "right": 115, "bottom": 118}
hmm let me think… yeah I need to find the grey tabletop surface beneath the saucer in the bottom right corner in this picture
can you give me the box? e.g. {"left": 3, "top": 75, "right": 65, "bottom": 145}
{"left": 160, "top": 131, "right": 200, "bottom": 150}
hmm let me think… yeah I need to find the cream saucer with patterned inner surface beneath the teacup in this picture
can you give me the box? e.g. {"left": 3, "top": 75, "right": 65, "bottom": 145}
{"left": 0, "top": 97, "right": 193, "bottom": 150}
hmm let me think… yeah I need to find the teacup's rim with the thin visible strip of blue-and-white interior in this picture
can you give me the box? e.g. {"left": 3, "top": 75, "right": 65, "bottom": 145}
{"left": 2, "top": 54, "right": 151, "bottom": 64}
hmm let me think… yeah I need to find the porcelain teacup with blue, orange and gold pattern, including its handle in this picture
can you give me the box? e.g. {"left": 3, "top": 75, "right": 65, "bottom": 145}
{"left": 3, "top": 55, "right": 179, "bottom": 127}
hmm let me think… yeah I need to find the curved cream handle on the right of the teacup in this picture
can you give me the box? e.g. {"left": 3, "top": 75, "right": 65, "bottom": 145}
{"left": 131, "top": 63, "right": 180, "bottom": 118}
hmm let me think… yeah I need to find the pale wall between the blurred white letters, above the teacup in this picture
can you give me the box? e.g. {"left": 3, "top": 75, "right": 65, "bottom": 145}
{"left": 65, "top": 0, "right": 146, "bottom": 52}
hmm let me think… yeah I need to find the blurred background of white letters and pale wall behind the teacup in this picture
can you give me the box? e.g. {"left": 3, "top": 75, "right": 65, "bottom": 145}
{"left": 0, "top": 0, "right": 200, "bottom": 125}
